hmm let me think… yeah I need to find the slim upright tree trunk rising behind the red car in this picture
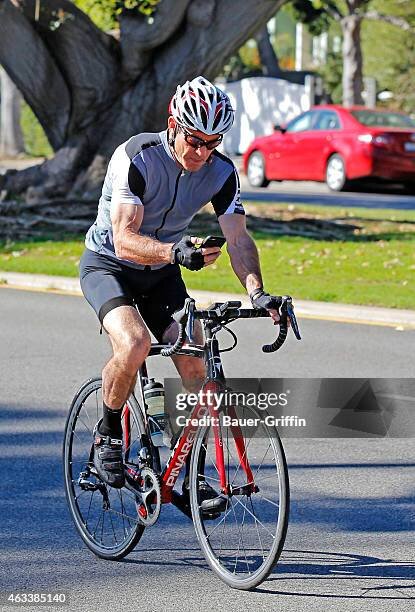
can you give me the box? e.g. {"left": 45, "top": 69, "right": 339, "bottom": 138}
{"left": 341, "top": 14, "right": 363, "bottom": 106}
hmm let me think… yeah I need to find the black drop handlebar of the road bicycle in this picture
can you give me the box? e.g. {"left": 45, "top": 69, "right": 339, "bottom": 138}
{"left": 161, "top": 295, "right": 301, "bottom": 357}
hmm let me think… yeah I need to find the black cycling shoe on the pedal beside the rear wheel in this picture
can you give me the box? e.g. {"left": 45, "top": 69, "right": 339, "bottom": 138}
{"left": 94, "top": 421, "right": 125, "bottom": 489}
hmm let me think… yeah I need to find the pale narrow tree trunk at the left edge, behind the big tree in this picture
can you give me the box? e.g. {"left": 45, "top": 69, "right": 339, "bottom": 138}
{"left": 0, "top": 66, "right": 24, "bottom": 157}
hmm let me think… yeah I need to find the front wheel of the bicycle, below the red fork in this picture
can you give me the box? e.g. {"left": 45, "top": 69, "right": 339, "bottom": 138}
{"left": 190, "top": 406, "right": 289, "bottom": 590}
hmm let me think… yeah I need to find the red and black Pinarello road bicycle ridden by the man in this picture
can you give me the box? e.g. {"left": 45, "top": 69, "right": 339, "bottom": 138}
{"left": 63, "top": 296, "right": 300, "bottom": 590}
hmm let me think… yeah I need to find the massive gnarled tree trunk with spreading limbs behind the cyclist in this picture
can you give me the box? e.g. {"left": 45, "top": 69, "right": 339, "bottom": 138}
{"left": 0, "top": 0, "right": 285, "bottom": 202}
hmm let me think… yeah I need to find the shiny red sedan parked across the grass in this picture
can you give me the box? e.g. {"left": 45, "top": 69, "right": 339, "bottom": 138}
{"left": 243, "top": 104, "right": 415, "bottom": 191}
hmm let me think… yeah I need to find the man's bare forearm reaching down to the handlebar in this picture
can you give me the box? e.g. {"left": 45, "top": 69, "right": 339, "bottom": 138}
{"left": 219, "top": 214, "right": 262, "bottom": 293}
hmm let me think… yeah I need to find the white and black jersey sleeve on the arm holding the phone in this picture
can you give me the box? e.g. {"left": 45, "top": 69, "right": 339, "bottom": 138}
{"left": 111, "top": 150, "right": 146, "bottom": 205}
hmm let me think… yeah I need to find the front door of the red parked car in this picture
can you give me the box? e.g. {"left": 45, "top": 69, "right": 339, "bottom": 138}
{"left": 276, "top": 111, "right": 322, "bottom": 180}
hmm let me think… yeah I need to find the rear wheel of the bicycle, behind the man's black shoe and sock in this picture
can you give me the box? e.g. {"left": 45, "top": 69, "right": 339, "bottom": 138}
{"left": 63, "top": 378, "right": 145, "bottom": 560}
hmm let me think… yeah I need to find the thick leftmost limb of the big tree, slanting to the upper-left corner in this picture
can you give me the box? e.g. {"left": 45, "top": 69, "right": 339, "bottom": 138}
{"left": 0, "top": 0, "right": 71, "bottom": 149}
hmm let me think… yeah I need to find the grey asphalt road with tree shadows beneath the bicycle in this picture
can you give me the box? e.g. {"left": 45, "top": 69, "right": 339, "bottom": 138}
{"left": 0, "top": 289, "right": 415, "bottom": 612}
